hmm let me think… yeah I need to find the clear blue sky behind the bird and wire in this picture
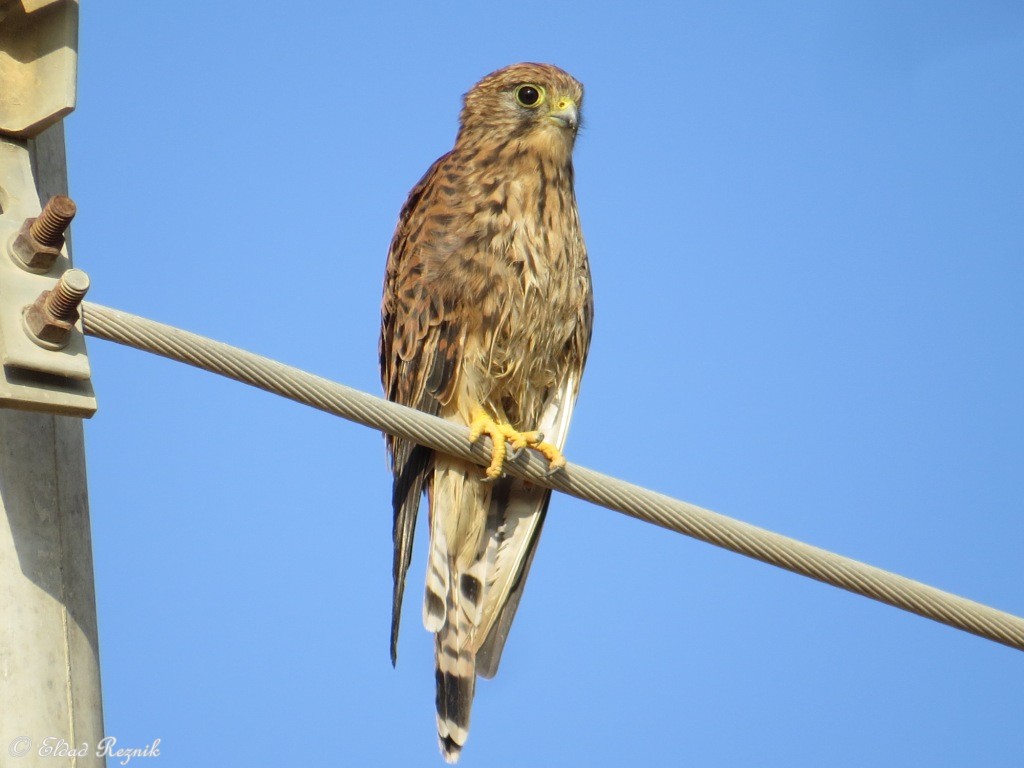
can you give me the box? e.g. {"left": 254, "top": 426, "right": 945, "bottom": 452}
{"left": 68, "top": 0, "right": 1024, "bottom": 768}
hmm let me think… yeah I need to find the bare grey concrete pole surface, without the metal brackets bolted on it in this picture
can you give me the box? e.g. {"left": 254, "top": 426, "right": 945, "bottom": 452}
{"left": 0, "top": 122, "right": 106, "bottom": 768}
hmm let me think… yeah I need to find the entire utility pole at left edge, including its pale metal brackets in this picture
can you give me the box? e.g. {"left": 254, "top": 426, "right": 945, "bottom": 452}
{"left": 0, "top": 0, "right": 105, "bottom": 768}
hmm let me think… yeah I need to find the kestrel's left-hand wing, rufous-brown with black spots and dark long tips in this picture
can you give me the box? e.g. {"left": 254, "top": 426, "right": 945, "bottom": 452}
{"left": 379, "top": 155, "right": 464, "bottom": 664}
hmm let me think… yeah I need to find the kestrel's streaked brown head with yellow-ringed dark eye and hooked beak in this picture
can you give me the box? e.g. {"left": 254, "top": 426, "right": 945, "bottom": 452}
{"left": 459, "top": 63, "right": 583, "bottom": 155}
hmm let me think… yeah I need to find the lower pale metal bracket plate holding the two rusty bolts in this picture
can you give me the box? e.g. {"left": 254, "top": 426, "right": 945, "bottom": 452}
{"left": 0, "top": 137, "right": 96, "bottom": 417}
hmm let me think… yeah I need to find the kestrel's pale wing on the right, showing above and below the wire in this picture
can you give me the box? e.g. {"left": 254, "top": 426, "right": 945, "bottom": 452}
{"left": 475, "top": 371, "right": 581, "bottom": 678}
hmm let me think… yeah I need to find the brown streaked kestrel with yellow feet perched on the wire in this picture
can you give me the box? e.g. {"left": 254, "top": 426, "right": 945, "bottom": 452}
{"left": 380, "top": 63, "right": 593, "bottom": 763}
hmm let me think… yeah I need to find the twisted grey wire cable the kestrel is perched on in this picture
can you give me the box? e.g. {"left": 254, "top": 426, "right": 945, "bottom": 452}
{"left": 82, "top": 302, "right": 1024, "bottom": 650}
